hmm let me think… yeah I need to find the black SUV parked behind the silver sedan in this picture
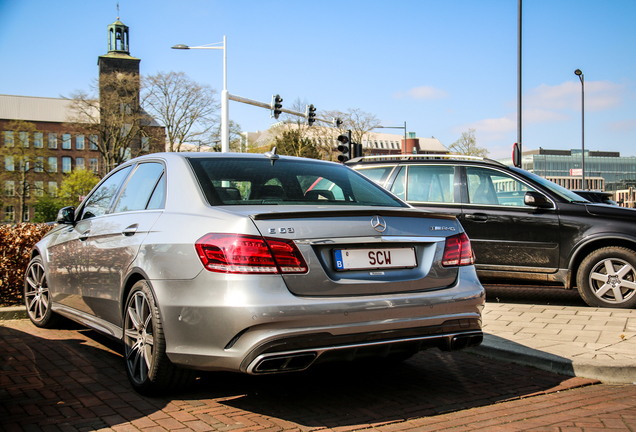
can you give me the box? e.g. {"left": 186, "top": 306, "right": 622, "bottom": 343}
{"left": 347, "top": 155, "right": 636, "bottom": 308}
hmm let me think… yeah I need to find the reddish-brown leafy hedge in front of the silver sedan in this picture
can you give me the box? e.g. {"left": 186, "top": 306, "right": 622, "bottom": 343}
{"left": 0, "top": 223, "right": 53, "bottom": 306}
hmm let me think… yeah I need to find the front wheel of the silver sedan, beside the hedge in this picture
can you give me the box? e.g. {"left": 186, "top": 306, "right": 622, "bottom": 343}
{"left": 23, "top": 256, "right": 60, "bottom": 328}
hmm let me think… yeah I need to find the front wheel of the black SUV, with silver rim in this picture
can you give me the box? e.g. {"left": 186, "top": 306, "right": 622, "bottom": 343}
{"left": 576, "top": 247, "right": 636, "bottom": 309}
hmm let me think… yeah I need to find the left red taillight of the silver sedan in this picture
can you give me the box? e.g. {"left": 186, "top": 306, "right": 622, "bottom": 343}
{"left": 195, "top": 234, "right": 307, "bottom": 274}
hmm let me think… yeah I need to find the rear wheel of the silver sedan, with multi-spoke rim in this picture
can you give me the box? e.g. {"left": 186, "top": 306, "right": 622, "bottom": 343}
{"left": 123, "top": 280, "right": 195, "bottom": 396}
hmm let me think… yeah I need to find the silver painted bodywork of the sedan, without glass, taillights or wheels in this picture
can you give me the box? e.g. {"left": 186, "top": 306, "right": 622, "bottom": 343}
{"left": 36, "top": 154, "right": 485, "bottom": 373}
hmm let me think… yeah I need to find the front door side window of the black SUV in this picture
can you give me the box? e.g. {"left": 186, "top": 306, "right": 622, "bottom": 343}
{"left": 466, "top": 167, "right": 534, "bottom": 207}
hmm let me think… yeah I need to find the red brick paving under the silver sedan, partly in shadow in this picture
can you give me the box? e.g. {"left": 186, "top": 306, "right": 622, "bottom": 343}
{"left": 0, "top": 320, "right": 636, "bottom": 432}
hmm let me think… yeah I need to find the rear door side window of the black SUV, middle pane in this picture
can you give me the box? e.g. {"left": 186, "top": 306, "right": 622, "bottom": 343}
{"left": 406, "top": 165, "right": 455, "bottom": 203}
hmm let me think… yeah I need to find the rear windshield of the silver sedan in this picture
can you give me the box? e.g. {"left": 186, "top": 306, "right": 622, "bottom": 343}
{"left": 189, "top": 157, "right": 408, "bottom": 207}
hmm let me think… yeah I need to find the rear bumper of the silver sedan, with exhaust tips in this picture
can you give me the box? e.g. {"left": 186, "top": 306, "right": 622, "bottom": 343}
{"left": 151, "top": 266, "right": 485, "bottom": 374}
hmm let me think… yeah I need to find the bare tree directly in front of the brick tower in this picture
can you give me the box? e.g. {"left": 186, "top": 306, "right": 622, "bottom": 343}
{"left": 67, "top": 72, "right": 153, "bottom": 172}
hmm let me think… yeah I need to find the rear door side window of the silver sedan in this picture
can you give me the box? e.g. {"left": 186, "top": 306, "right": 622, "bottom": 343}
{"left": 114, "top": 163, "right": 163, "bottom": 213}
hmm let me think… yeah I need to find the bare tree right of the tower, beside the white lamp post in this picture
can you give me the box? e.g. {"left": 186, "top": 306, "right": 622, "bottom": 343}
{"left": 142, "top": 72, "right": 219, "bottom": 152}
